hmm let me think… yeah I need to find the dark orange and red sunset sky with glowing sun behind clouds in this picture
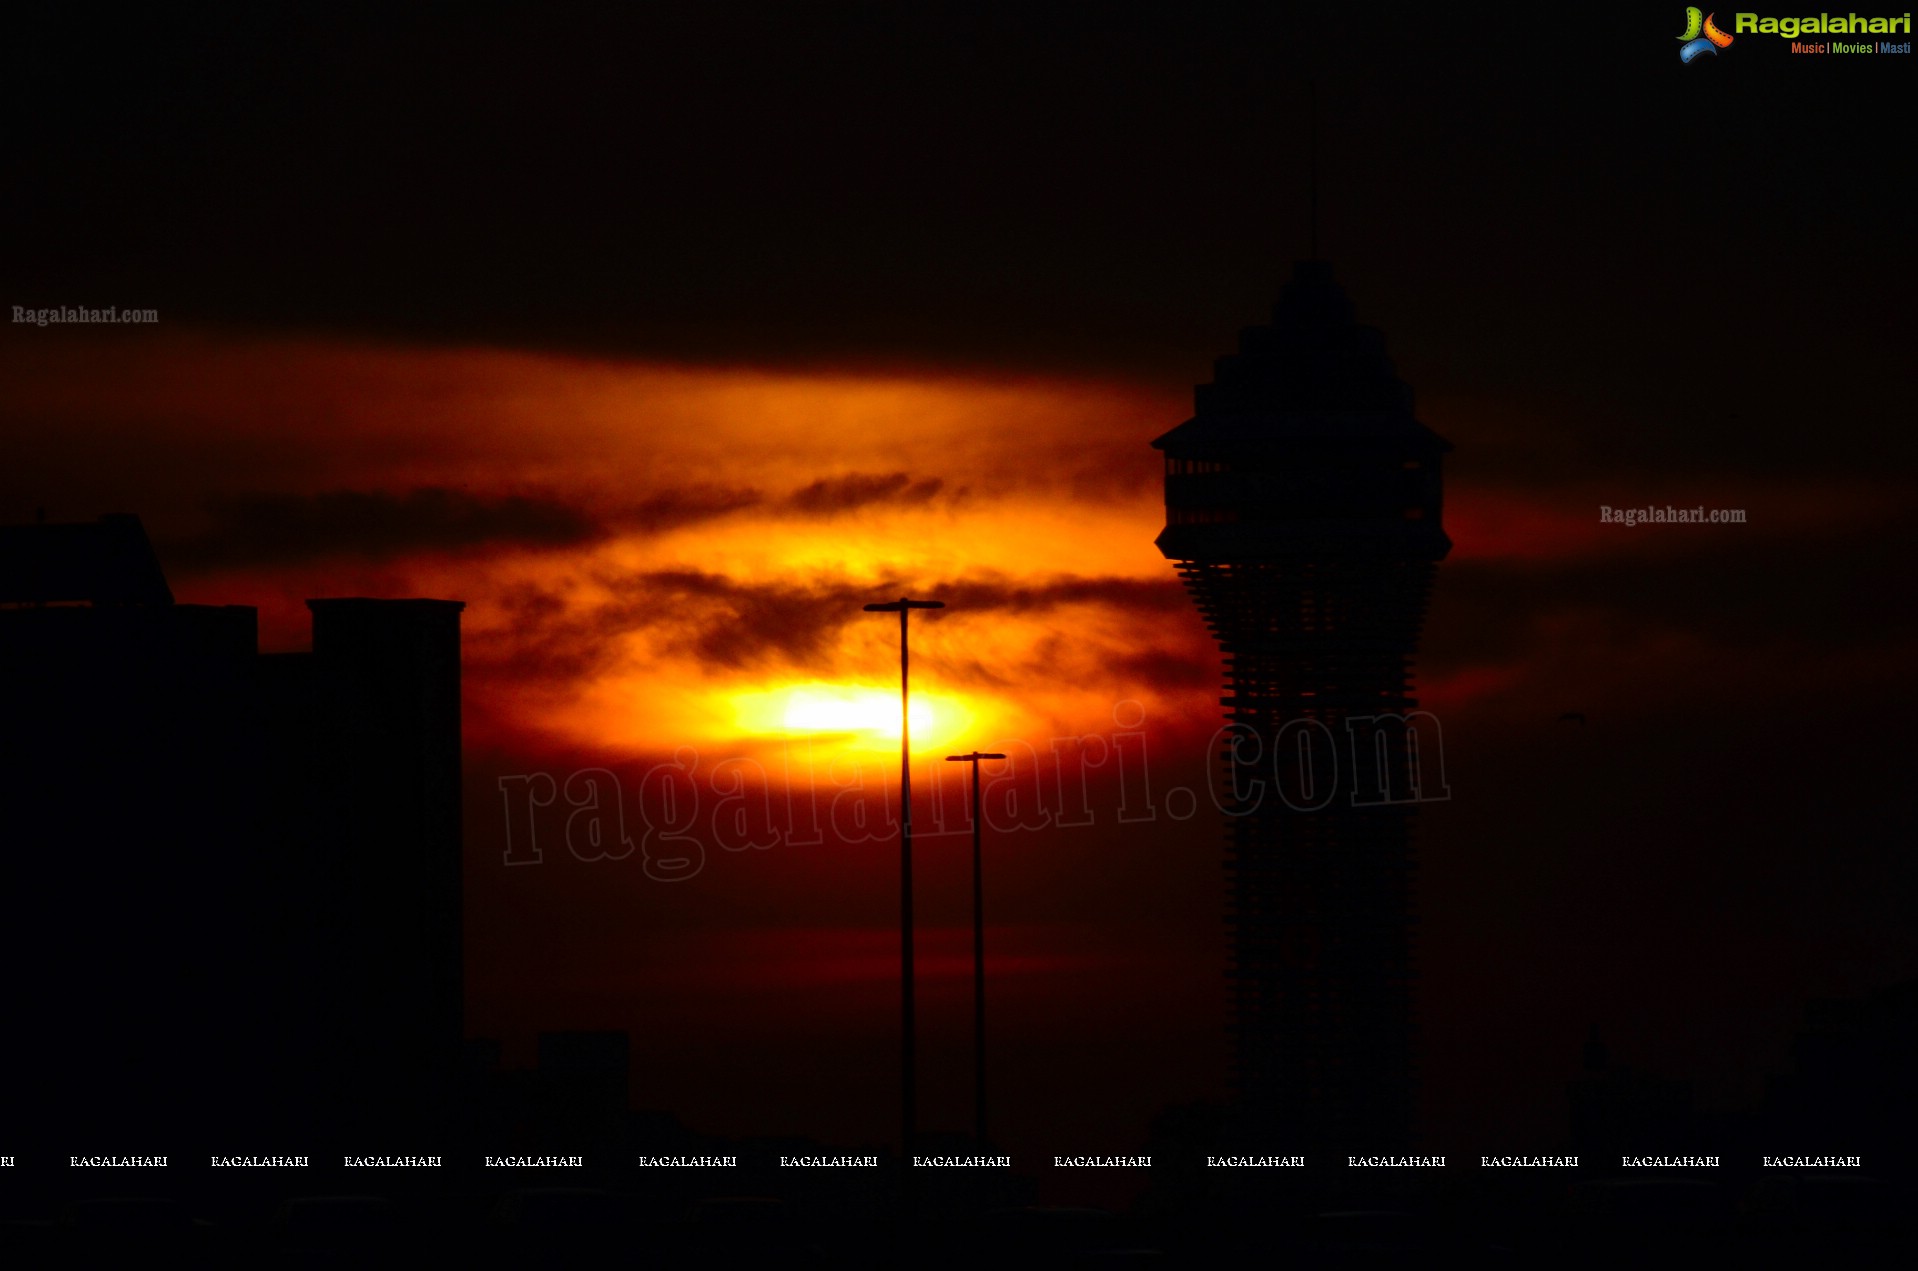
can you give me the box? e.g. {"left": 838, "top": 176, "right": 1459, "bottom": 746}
{"left": 0, "top": 6, "right": 1918, "bottom": 1196}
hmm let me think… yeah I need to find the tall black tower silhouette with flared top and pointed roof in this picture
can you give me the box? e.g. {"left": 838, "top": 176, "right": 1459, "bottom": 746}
{"left": 1153, "top": 261, "right": 1452, "bottom": 1152}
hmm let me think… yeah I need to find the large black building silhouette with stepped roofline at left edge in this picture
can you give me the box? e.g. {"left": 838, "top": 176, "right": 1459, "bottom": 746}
{"left": 0, "top": 516, "right": 464, "bottom": 1154}
